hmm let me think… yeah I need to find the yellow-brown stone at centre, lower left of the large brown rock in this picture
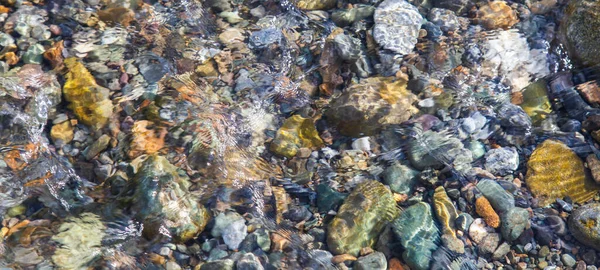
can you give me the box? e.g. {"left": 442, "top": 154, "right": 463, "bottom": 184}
{"left": 271, "top": 115, "right": 323, "bottom": 158}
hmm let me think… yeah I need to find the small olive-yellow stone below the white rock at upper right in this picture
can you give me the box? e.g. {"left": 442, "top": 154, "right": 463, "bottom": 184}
{"left": 520, "top": 80, "right": 552, "bottom": 125}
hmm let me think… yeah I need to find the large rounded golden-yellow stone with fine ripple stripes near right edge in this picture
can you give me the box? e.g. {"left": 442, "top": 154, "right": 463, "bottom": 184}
{"left": 525, "top": 140, "right": 599, "bottom": 207}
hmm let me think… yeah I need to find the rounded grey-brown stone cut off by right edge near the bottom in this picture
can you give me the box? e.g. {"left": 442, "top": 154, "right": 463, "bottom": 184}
{"left": 569, "top": 203, "right": 600, "bottom": 250}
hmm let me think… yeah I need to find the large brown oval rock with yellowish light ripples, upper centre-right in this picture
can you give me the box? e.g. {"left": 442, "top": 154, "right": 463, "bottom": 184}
{"left": 325, "top": 77, "right": 416, "bottom": 137}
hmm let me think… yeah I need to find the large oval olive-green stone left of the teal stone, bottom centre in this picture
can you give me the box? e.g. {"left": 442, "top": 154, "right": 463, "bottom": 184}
{"left": 327, "top": 180, "right": 399, "bottom": 256}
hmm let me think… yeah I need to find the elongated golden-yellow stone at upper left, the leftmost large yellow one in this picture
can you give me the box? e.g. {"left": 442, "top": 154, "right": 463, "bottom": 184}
{"left": 63, "top": 57, "right": 113, "bottom": 129}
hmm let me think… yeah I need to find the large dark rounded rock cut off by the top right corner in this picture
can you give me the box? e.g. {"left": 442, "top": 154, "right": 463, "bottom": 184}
{"left": 560, "top": 0, "right": 600, "bottom": 66}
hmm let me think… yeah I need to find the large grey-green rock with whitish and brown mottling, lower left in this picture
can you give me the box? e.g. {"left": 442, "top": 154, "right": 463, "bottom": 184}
{"left": 122, "top": 155, "right": 210, "bottom": 242}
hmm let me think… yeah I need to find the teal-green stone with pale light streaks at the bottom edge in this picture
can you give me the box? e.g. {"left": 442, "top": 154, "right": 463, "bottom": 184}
{"left": 392, "top": 202, "right": 440, "bottom": 270}
